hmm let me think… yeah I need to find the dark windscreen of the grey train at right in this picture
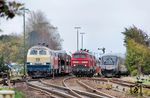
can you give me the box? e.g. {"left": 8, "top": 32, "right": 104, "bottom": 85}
{"left": 102, "top": 56, "right": 117, "bottom": 65}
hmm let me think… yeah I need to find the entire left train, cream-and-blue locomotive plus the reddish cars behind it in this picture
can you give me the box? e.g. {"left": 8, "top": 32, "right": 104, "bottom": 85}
{"left": 27, "top": 45, "right": 71, "bottom": 78}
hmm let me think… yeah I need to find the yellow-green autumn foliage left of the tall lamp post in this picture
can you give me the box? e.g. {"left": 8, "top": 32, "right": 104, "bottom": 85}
{"left": 0, "top": 34, "right": 23, "bottom": 64}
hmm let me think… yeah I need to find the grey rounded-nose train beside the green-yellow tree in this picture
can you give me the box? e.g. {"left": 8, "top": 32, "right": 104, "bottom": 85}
{"left": 101, "top": 54, "right": 128, "bottom": 77}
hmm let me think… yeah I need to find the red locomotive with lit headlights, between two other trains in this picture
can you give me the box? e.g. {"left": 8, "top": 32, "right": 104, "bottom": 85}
{"left": 71, "top": 50, "right": 96, "bottom": 76}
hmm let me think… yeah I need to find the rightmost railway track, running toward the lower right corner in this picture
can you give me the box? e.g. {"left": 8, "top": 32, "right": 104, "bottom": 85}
{"left": 89, "top": 78, "right": 149, "bottom": 98}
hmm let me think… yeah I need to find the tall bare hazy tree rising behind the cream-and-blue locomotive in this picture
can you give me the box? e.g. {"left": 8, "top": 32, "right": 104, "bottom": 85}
{"left": 26, "top": 11, "right": 63, "bottom": 50}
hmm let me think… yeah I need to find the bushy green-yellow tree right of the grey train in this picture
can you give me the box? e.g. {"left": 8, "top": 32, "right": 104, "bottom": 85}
{"left": 123, "top": 26, "right": 150, "bottom": 75}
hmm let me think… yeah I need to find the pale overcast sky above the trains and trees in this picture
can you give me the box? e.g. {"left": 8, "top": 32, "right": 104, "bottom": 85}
{"left": 0, "top": 0, "right": 150, "bottom": 53}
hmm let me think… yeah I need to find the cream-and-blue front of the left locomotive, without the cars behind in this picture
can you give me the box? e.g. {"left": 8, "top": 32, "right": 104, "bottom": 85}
{"left": 26, "top": 45, "right": 52, "bottom": 78}
